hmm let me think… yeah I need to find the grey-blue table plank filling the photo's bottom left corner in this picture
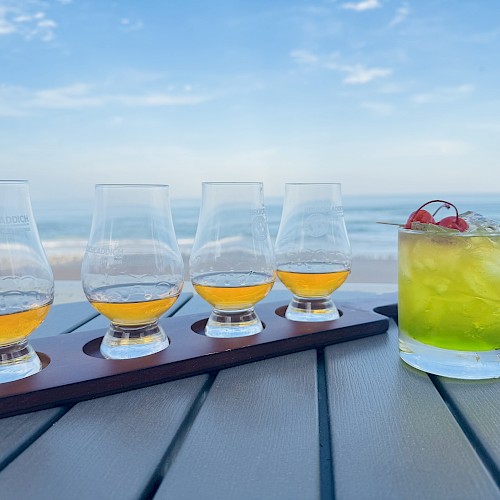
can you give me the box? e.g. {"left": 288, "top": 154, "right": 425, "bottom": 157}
{"left": 0, "top": 375, "right": 207, "bottom": 500}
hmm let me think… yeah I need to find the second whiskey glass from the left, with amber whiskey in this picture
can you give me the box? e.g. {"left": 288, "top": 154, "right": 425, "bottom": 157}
{"left": 82, "top": 184, "right": 184, "bottom": 359}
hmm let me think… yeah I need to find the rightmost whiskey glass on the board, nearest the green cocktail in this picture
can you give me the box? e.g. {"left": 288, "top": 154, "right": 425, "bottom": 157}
{"left": 275, "top": 183, "right": 351, "bottom": 321}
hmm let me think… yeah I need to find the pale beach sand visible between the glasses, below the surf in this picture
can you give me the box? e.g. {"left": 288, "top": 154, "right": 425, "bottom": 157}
{"left": 49, "top": 256, "right": 398, "bottom": 304}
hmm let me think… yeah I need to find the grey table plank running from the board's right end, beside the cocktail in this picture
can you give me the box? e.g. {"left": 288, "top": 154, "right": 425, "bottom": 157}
{"left": 325, "top": 323, "right": 500, "bottom": 499}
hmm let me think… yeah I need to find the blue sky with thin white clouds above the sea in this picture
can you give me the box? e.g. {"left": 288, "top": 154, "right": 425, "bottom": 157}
{"left": 0, "top": 0, "right": 500, "bottom": 202}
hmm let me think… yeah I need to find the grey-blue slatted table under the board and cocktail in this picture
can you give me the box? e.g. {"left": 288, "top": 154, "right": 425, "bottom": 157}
{"left": 0, "top": 290, "right": 500, "bottom": 500}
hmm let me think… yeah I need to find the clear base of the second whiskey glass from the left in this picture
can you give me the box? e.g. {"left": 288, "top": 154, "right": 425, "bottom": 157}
{"left": 100, "top": 323, "right": 170, "bottom": 359}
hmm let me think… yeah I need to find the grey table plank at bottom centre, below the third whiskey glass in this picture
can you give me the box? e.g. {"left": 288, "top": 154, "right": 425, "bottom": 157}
{"left": 155, "top": 351, "right": 320, "bottom": 500}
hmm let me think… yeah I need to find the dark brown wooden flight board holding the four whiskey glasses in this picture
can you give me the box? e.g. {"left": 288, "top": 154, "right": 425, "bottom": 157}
{"left": 0, "top": 302, "right": 389, "bottom": 417}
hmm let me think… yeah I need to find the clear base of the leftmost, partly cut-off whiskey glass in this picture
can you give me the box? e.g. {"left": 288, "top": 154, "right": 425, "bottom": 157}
{"left": 0, "top": 340, "right": 42, "bottom": 383}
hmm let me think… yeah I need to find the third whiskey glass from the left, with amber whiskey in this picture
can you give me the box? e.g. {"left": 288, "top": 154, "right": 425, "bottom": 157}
{"left": 189, "top": 182, "right": 276, "bottom": 338}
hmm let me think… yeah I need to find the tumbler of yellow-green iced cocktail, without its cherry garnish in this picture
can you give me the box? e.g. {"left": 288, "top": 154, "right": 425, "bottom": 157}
{"left": 398, "top": 228, "right": 500, "bottom": 379}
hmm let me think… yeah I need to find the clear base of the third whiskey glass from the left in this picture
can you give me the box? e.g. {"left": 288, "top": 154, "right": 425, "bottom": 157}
{"left": 205, "top": 308, "right": 264, "bottom": 338}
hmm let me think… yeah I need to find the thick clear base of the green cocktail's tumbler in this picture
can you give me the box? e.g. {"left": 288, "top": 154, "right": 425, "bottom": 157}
{"left": 399, "top": 331, "right": 500, "bottom": 380}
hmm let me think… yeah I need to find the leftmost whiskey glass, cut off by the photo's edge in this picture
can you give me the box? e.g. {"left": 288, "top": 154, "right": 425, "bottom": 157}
{"left": 0, "top": 181, "right": 54, "bottom": 383}
